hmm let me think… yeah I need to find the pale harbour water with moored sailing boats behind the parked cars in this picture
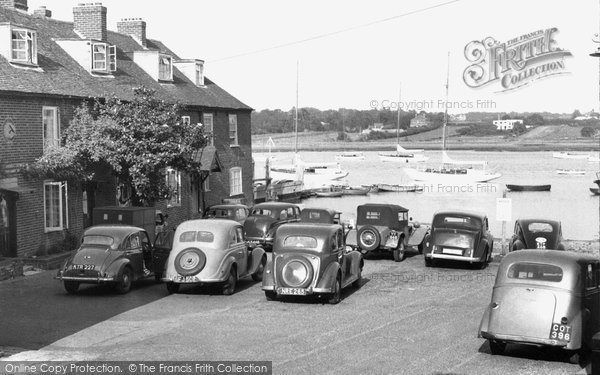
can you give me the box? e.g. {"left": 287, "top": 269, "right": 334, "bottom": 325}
{"left": 255, "top": 151, "right": 600, "bottom": 240}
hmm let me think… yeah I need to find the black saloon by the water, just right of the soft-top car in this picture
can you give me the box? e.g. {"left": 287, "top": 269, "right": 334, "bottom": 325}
{"left": 423, "top": 211, "right": 494, "bottom": 268}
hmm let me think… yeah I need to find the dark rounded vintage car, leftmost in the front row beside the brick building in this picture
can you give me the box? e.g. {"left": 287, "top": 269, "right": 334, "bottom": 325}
{"left": 56, "top": 224, "right": 168, "bottom": 293}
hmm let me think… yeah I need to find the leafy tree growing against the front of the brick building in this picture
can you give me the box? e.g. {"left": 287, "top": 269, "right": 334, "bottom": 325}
{"left": 26, "top": 88, "right": 206, "bottom": 206}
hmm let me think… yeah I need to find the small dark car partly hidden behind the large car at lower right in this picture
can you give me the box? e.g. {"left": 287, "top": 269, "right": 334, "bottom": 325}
{"left": 508, "top": 219, "right": 565, "bottom": 251}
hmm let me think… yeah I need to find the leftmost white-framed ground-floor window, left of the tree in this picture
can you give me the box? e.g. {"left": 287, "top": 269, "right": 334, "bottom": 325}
{"left": 44, "top": 181, "right": 69, "bottom": 232}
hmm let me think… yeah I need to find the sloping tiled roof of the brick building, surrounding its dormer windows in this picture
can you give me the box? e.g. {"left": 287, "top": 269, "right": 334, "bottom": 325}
{"left": 0, "top": 7, "right": 251, "bottom": 110}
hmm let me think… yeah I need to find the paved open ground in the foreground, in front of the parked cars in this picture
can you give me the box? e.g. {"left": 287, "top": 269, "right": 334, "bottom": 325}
{"left": 0, "top": 255, "right": 585, "bottom": 374}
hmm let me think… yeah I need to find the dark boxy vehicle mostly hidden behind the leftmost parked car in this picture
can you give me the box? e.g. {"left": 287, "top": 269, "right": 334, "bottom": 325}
{"left": 92, "top": 206, "right": 156, "bottom": 242}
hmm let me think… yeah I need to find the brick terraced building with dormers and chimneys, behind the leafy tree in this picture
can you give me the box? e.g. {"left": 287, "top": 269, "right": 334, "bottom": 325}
{"left": 0, "top": 0, "right": 253, "bottom": 257}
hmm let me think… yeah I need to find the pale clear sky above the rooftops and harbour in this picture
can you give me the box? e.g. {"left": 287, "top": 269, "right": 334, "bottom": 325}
{"left": 28, "top": 0, "right": 600, "bottom": 113}
